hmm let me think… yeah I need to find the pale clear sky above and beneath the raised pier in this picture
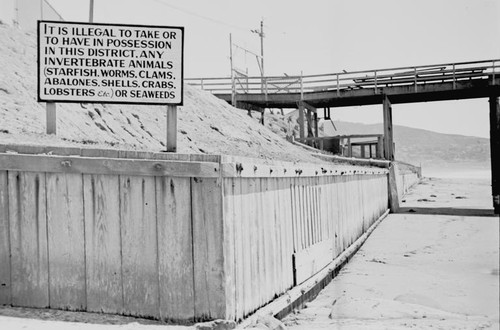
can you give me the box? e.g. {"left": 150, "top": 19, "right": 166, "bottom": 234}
{"left": 2, "top": 0, "right": 500, "bottom": 137}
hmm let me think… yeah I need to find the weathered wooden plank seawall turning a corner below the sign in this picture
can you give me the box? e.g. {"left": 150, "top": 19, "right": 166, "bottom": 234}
{"left": 0, "top": 146, "right": 416, "bottom": 321}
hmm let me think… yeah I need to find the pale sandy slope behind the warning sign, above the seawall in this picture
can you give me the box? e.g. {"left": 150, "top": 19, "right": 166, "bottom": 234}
{"left": 0, "top": 24, "right": 328, "bottom": 162}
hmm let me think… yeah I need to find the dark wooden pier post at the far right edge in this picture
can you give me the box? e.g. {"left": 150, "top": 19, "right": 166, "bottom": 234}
{"left": 490, "top": 97, "right": 500, "bottom": 214}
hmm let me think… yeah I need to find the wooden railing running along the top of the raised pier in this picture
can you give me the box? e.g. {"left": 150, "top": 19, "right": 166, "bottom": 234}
{"left": 185, "top": 59, "right": 500, "bottom": 95}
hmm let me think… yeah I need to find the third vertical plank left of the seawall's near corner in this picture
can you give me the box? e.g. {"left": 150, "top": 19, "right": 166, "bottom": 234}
{"left": 120, "top": 175, "right": 160, "bottom": 318}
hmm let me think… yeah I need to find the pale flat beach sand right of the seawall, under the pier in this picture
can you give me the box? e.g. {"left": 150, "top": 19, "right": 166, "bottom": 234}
{"left": 284, "top": 179, "right": 500, "bottom": 330}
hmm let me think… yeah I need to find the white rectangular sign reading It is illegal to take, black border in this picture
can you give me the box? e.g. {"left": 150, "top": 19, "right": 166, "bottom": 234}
{"left": 38, "top": 21, "right": 184, "bottom": 105}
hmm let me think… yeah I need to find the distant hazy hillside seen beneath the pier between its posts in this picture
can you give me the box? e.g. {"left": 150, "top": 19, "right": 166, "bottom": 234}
{"left": 260, "top": 111, "right": 491, "bottom": 177}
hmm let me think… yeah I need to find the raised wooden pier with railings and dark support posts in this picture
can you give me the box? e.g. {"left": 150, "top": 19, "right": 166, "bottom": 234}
{"left": 186, "top": 59, "right": 500, "bottom": 214}
